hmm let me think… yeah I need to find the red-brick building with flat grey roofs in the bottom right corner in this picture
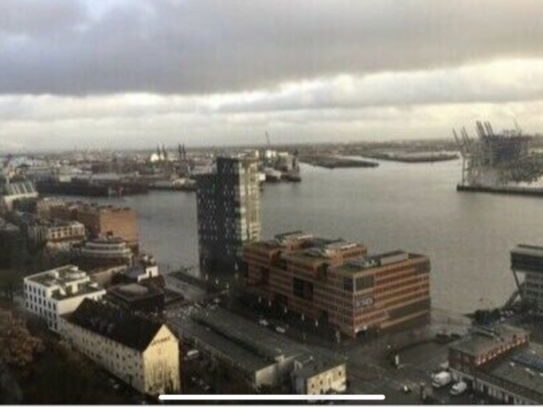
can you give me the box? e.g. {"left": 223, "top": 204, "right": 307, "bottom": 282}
{"left": 449, "top": 325, "right": 543, "bottom": 404}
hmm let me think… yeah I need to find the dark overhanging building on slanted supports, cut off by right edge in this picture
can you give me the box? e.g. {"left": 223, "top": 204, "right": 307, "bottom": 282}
{"left": 511, "top": 244, "right": 543, "bottom": 309}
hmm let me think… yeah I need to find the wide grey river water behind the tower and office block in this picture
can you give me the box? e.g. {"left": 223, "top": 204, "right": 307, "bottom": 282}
{"left": 87, "top": 160, "right": 543, "bottom": 313}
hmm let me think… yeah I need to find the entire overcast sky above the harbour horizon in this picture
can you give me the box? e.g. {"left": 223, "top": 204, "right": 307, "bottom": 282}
{"left": 0, "top": 0, "right": 543, "bottom": 153}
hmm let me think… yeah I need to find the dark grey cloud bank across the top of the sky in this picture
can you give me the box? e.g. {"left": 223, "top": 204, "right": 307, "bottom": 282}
{"left": 0, "top": 0, "right": 543, "bottom": 95}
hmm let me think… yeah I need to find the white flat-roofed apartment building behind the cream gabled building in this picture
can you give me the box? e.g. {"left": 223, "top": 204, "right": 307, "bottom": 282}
{"left": 24, "top": 265, "right": 106, "bottom": 332}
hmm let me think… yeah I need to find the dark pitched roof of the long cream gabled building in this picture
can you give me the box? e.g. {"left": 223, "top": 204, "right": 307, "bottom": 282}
{"left": 67, "top": 299, "right": 163, "bottom": 352}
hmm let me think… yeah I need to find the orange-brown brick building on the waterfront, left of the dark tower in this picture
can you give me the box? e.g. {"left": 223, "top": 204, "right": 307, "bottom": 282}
{"left": 50, "top": 202, "right": 138, "bottom": 248}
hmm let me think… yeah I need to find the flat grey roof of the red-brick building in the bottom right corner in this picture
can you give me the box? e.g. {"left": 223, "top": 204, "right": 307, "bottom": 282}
{"left": 449, "top": 325, "right": 528, "bottom": 356}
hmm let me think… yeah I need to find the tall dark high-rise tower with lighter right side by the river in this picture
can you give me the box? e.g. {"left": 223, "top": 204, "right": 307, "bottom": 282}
{"left": 196, "top": 157, "right": 261, "bottom": 274}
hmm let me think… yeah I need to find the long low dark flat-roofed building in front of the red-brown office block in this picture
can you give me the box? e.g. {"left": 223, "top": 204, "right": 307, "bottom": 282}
{"left": 170, "top": 308, "right": 345, "bottom": 389}
